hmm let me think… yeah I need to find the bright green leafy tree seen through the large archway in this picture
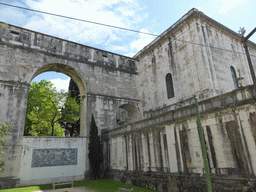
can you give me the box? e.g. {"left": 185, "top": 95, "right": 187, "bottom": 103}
{"left": 24, "top": 80, "right": 80, "bottom": 136}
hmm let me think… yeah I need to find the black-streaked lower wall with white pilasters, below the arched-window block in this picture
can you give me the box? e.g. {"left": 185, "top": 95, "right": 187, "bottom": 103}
{"left": 109, "top": 87, "right": 256, "bottom": 191}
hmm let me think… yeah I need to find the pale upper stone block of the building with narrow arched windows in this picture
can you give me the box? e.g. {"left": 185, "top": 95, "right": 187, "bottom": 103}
{"left": 134, "top": 10, "right": 256, "bottom": 117}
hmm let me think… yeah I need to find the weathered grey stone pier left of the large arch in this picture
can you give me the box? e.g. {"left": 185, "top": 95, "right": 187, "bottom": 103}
{"left": 0, "top": 81, "right": 30, "bottom": 188}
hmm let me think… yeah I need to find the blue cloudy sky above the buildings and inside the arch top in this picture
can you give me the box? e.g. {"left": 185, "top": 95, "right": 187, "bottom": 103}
{"left": 0, "top": 0, "right": 256, "bottom": 89}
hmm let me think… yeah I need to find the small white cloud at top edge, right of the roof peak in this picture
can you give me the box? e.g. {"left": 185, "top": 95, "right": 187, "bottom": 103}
{"left": 214, "top": 0, "right": 248, "bottom": 14}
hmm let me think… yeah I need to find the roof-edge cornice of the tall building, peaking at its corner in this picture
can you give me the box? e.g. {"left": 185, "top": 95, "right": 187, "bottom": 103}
{"left": 133, "top": 8, "right": 256, "bottom": 60}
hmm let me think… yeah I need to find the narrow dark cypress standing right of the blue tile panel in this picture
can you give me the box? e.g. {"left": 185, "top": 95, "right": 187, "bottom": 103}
{"left": 88, "top": 114, "right": 103, "bottom": 179}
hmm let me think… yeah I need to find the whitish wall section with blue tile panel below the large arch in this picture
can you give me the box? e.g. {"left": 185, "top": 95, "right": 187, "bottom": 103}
{"left": 19, "top": 137, "right": 87, "bottom": 186}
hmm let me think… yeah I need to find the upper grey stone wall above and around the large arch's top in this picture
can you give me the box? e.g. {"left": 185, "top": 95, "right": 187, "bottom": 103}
{"left": 0, "top": 22, "right": 138, "bottom": 132}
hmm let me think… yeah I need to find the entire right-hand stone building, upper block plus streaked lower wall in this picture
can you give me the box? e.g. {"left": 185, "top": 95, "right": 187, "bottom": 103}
{"left": 108, "top": 9, "right": 256, "bottom": 191}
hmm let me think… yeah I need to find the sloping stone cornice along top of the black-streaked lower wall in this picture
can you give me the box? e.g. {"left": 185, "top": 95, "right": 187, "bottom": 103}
{"left": 109, "top": 86, "right": 255, "bottom": 137}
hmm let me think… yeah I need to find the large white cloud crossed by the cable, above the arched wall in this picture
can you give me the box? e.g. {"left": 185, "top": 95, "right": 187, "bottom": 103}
{"left": 25, "top": 0, "right": 147, "bottom": 45}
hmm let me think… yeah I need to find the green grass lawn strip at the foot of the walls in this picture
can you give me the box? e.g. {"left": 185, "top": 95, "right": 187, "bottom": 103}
{"left": 0, "top": 179, "right": 157, "bottom": 192}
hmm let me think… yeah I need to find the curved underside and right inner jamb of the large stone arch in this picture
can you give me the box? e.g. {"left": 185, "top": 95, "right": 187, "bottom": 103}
{"left": 30, "top": 63, "right": 88, "bottom": 136}
